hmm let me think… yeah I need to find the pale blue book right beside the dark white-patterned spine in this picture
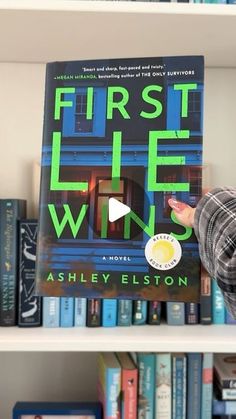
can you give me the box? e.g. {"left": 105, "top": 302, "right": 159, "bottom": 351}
{"left": 43, "top": 297, "right": 60, "bottom": 327}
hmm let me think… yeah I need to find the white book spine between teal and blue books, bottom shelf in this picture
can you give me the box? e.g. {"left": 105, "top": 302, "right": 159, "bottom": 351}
{"left": 155, "top": 354, "right": 172, "bottom": 419}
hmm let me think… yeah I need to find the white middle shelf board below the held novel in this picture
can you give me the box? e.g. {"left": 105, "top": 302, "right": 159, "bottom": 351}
{"left": 0, "top": 325, "right": 236, "bottom": 353}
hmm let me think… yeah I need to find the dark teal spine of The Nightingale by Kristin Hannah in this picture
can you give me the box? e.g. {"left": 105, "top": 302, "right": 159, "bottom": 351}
{"left": 0, "top": 199, "right": 26, "bottom": 326}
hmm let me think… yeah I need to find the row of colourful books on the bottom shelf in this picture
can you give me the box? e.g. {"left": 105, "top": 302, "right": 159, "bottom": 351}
{"left": 98, "top": 353, "right": 236, "bottom": 419}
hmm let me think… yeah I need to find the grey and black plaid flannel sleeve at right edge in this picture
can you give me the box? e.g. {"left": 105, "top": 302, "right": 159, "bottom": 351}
{"left": 194, "top": 187, "right": 236, "bottom": 319}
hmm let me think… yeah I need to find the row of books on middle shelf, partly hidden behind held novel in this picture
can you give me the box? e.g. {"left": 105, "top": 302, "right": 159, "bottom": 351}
{"left": 0, "top": 199, "right": 235, "bottom": 327}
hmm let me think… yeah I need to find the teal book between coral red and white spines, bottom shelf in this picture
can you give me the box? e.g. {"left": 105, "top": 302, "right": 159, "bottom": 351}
{"left": 138, "top": 353, "right": 156, "bottom": 419}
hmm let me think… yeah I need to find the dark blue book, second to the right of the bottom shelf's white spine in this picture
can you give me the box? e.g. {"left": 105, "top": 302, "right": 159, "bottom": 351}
{"left": 187, "top": 353, "right": 202, "bottom": 419}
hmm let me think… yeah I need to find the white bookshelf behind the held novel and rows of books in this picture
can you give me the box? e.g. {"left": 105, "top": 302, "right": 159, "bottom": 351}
{"left": 0, "top": 0, "right": 236, "bottom": 419}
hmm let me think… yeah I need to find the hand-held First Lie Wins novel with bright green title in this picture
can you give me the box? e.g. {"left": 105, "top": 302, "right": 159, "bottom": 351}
{"left": 37, "top": 56, "right": 204, "bottom": 302}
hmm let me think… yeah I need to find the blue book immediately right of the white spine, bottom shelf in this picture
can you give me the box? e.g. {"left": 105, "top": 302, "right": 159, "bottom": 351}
{"left": 171, "top": 353, "right": 187, "bottom": 419}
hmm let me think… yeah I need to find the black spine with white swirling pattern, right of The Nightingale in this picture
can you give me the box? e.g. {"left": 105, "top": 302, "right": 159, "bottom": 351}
{"left": 18, "top": 220, "right": 42, "bottom": 327}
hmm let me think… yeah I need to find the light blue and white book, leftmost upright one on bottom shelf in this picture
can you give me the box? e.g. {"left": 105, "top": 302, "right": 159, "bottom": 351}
{"left": 98, "top": 352, "right": 121, "bottom": 419}
